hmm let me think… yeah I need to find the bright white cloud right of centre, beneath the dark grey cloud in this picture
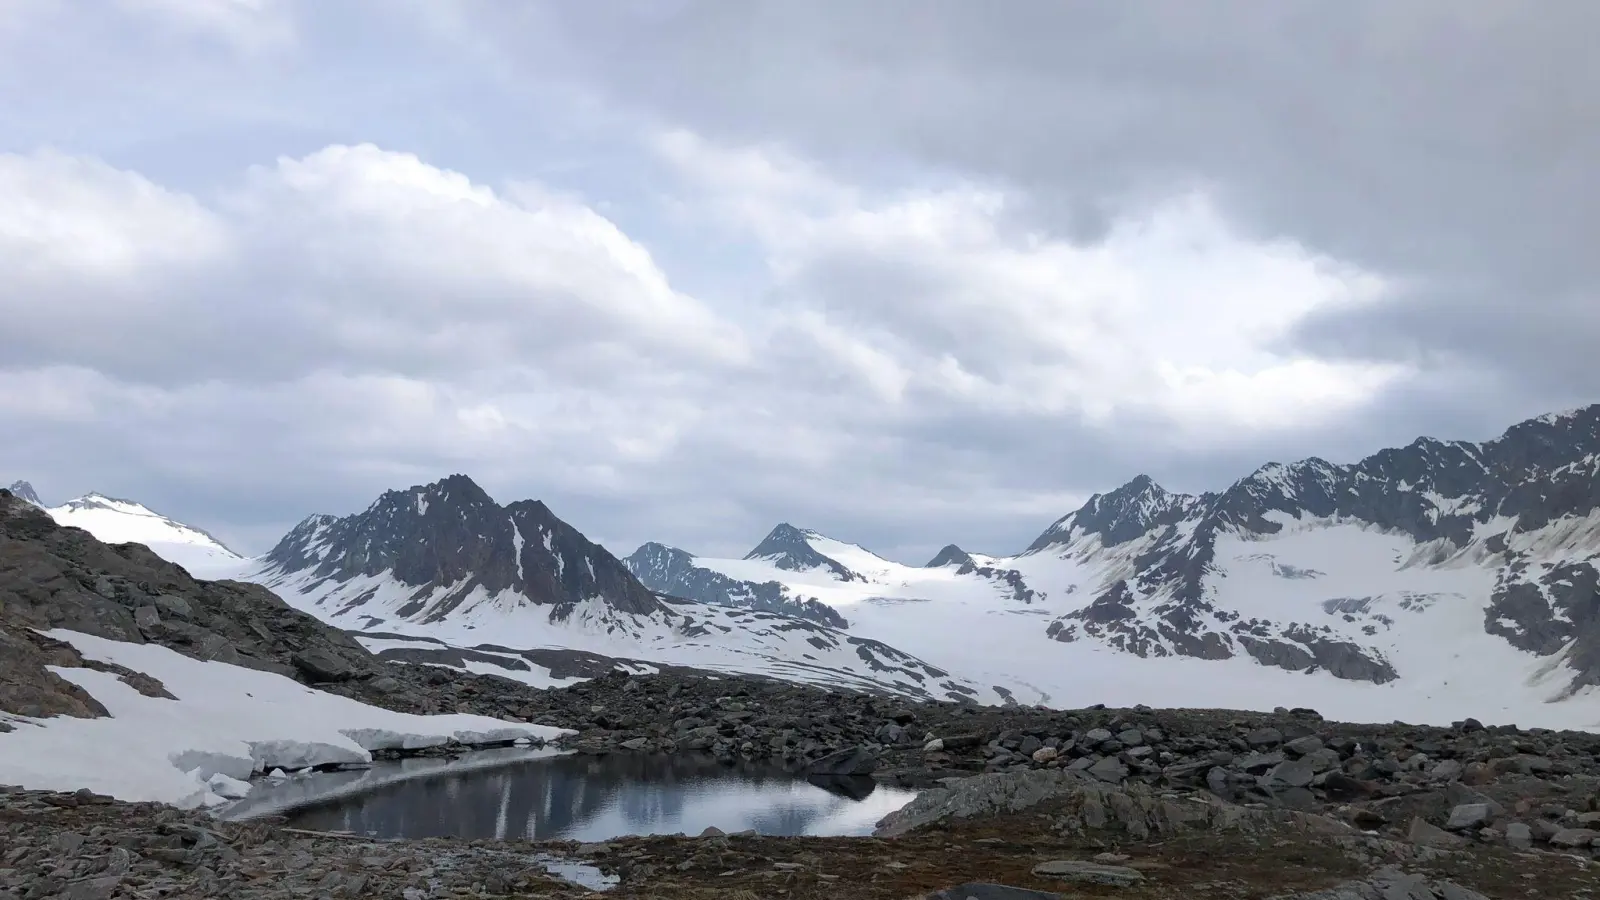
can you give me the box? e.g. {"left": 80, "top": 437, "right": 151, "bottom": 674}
{"left": 654, "top": 131, "right": 1403, "bottom": 437}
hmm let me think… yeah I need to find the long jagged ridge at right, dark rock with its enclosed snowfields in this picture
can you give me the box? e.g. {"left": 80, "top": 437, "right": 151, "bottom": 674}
{"left": 1029, "top": 405, "right": 1600, "bottom": 700}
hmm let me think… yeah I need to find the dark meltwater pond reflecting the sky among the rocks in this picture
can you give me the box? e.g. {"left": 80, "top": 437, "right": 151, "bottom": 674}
{"left": 224, "top": 749, "right": 915, "bottom": 841}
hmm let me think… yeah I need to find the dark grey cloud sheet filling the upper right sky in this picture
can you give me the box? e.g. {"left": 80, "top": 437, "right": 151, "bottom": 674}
{"left": 478, "top": 0, "right": 1600, "bottom": 412}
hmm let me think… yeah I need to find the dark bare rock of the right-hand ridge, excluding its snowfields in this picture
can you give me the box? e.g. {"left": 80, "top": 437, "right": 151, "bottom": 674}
{"left": 1027, "top": 405, "right": 1600, "bottom": 692}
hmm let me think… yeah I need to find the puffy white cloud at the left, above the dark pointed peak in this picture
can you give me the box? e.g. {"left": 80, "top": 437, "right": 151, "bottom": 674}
{"left": 0, "top": 146, "right": 749, "bottom": 381}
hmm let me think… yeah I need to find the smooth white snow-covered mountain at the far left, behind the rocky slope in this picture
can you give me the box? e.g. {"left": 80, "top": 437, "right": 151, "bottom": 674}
{"left": 11, "top": 480, "right": 245, "bottom": 578}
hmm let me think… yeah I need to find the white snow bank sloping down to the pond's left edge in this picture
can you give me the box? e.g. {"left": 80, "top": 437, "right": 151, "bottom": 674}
{"left": 0, "top": 629, "right": 565, "bottom": 807}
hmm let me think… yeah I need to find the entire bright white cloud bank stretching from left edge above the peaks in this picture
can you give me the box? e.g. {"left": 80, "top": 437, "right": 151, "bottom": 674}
{"left": 0, "top": 133, "right": 1401, "bottom": 557}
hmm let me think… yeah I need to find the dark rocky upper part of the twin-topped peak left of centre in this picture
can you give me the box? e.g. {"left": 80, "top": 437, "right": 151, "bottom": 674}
{"left": 266, "top": 474, "right": 661, "bottom": 623}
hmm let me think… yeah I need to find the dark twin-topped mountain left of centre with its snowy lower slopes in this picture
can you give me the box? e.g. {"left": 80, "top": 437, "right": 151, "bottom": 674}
{"left": 240, "top": 476, "right": 1002, "bottom": 701}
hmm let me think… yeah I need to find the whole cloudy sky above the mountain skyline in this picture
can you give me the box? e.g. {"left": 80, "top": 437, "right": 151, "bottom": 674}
{"left": 0, "top": 0, "right": 1600, "bottom": 562}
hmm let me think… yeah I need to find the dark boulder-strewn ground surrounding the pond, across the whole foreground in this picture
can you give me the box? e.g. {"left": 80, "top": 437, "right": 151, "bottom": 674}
{"left": 0, "top": 669, "right": 1600, "bottom": 900}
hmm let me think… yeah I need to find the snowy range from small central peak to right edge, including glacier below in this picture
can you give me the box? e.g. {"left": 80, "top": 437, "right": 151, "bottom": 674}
{"left": 620, "top": 405, "right": 1600, "bottom": 729}
